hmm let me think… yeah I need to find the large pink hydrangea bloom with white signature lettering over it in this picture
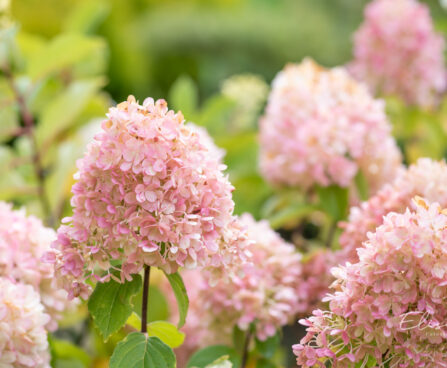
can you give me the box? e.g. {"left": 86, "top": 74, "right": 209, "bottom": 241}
{"left": 293, "top": 197, "right": 447, "bottom": 368}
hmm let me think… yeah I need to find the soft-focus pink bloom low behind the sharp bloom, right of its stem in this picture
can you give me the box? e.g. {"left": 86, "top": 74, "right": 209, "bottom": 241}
{"left": 177, "top": 214, "right": 302, "bottom": 345}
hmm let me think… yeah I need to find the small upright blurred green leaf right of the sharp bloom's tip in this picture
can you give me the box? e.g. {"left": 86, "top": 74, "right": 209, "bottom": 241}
{"left": 169, "top": 75, "right": 199, "bottom": 120}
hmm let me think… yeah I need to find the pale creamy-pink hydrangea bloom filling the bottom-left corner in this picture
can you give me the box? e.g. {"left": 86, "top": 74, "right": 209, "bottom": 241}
{"left": 0, "top": 277, "right": 50, "bottom": 368}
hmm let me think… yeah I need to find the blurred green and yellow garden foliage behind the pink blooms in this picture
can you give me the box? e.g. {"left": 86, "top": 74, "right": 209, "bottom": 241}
{"left": 0, "top": 0, "right": 447, "bottom": 368}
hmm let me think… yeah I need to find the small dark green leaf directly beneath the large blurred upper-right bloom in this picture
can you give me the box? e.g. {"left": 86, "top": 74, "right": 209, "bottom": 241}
{"left": 317, "top": 185, "right": 349, "bottom": 221}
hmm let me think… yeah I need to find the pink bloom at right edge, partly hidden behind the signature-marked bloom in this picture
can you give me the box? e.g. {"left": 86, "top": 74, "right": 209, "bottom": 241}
{"left": 338, "top": 158, "right": 447, "bottom": 263}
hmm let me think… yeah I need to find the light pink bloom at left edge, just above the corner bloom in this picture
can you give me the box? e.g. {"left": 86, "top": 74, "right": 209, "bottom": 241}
{"left": 0, "top": 202, "right": 70, "bottom": 330}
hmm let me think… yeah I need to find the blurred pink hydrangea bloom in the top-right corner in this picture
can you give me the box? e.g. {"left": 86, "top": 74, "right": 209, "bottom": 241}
{"left": 349, "top": 0, "right": 447, "bottom": 106}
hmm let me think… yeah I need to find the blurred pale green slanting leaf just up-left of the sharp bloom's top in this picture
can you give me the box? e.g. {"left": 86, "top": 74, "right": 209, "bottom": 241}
{"left": 36, "top": 78, "right": 104, "bottom": 146}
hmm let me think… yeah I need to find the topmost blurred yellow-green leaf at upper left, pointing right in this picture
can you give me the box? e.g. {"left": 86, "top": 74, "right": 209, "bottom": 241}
{"left": 28, "top": 33, "right": 104, "bottom": 80}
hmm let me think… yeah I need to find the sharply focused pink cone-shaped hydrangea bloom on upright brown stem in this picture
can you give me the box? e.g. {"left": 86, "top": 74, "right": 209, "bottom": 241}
{"left": 48, "top": 96, "right": 239, "bottom": 297}
